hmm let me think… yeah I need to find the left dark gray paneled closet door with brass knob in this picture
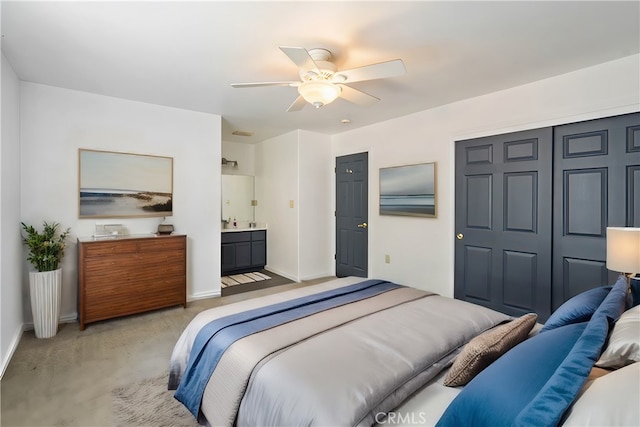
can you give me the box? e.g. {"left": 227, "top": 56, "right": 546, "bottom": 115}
{"left": 454, "top": 128, "right": 552, "bottom": 321}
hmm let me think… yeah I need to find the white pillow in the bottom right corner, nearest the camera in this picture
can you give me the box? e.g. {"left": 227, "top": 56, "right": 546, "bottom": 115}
{"left": 562, "top": 363, "right": 640, "bottom": 427}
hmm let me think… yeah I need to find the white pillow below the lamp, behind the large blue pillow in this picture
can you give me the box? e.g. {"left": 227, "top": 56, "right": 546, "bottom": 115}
{"left": 596, "top": 305, "right": 640, "bottom": 368}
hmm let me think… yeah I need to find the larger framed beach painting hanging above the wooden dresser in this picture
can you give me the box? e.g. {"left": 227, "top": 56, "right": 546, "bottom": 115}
{"left": 78, "top": 148, "right": 173, "bottom": 218}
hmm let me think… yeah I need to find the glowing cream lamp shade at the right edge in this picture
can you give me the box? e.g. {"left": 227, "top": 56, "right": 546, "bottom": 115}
{"left": 607, "top": 227, "right": 640, "bottom": 274}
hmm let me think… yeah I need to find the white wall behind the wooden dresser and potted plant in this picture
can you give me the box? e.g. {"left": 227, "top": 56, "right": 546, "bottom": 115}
{"left": 20, "top": 82, "right": 221, "bottom": 322}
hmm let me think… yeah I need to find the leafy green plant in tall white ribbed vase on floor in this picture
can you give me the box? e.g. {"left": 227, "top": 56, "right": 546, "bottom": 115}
{"left": 22, "top": 221, "right": 71, "bottom": 338}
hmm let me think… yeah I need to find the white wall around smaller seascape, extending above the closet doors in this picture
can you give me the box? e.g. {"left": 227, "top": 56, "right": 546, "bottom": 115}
{"left": 332, "top": 55, "right": 640, "bottom": 296}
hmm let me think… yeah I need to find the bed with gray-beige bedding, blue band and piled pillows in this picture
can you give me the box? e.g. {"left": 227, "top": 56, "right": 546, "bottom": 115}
{"left": 169, "top": 277, "right": 640, "bottom": 426}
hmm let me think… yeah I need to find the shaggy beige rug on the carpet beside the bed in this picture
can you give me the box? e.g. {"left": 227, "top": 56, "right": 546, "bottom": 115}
{"left": 111, "top": 375, "right": 200, "bottom": 427}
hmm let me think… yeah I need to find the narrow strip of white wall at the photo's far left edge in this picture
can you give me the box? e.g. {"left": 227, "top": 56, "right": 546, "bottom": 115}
{"left": 0, "top": 54, "right": 23, "bottom": 378}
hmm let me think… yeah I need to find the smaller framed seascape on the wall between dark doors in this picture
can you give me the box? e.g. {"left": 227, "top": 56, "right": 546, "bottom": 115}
{"left": 380, "top": 162, "right": 436, "bottom": 218}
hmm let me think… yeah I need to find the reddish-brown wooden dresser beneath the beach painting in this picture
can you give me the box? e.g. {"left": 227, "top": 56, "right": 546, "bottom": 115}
{"left": 78, "top": 235, "right": 187, "bottom": 330}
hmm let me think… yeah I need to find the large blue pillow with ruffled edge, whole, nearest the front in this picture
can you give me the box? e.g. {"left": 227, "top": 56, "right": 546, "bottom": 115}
{"left": 437, "top": 277, "right": 627, "bottom": 427}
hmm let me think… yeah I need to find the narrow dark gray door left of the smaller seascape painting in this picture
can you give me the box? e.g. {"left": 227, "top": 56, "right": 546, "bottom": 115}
{"left": 336, "top": 153, "right": 369, "bottom": 277}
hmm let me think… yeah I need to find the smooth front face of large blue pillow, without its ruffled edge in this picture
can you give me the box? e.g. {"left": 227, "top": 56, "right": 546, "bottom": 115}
{"left": 437, "top": 322, "right": 587, "bottom": 427}
